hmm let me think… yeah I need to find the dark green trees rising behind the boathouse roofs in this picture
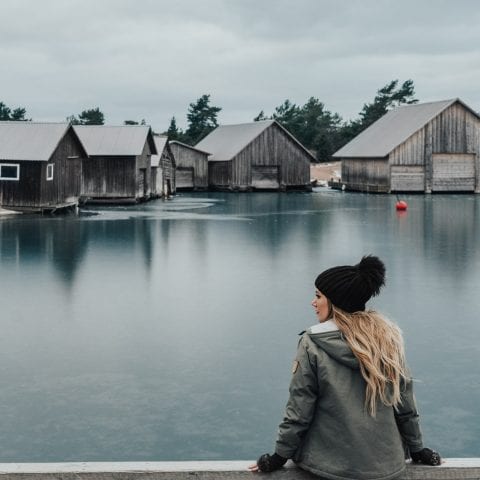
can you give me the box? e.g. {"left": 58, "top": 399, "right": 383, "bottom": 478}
{"left": 0, "top": 80, "right": 418, "bottom": 162}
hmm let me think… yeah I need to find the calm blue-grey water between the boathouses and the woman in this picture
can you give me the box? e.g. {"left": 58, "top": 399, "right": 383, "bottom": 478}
{"left": 0, "top": 190, "right": 480, "bottom": 462}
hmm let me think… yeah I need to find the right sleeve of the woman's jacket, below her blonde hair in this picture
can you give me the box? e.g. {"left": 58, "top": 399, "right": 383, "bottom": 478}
{"left": 394, "top": 378, "right": 423, "bottom": 452}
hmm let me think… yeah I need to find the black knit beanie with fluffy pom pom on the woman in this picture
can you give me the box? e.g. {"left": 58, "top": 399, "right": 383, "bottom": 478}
{"left": 315, "top": 255, "right": 385, "bottom": 313}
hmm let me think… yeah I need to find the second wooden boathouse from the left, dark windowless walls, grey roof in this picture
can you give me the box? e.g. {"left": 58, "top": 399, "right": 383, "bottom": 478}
{"left": 73, "top": 125, "right": 157, "bottom": 203}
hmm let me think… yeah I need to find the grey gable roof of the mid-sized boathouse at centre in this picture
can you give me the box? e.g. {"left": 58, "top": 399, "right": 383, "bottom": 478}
{"left": 195, "top": 120, "right": 315, "bottom": 162}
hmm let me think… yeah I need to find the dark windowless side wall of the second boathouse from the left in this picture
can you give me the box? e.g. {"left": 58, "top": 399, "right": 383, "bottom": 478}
{"left": 82, "top": 157, "right": 136, "bottom": 199}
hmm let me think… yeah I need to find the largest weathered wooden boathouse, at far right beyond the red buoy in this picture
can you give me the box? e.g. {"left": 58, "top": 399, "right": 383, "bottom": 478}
{"left": 333, "top": 99, "right": 480, "bottom": 193}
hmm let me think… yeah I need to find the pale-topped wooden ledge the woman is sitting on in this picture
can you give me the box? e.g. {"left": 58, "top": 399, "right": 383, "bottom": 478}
{"left": 0, "top": 458, "right": 480, "bottom": 480}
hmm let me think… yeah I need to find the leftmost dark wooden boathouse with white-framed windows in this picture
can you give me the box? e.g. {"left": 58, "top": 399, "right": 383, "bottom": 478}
{"left": 0, "top": 121, "right": 87, "bottom": 213}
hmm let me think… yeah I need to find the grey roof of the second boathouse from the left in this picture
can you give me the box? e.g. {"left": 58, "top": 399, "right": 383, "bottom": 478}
{"left": 73, "top": 125, "right": 156, "bottom": 156}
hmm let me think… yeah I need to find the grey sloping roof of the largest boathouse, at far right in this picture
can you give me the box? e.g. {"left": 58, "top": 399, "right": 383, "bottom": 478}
{"left": 333, "top": 98, "right": 480, "bottom": 158}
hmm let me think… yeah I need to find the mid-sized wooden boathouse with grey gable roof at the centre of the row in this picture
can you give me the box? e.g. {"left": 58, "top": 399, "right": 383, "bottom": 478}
{"left": 195, "top": 120, "right": 315, "bottom": 191}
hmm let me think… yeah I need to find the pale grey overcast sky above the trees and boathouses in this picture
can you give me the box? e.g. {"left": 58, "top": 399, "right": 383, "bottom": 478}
{"left": 0, "top": 0, "right": 480, "bottom": 131}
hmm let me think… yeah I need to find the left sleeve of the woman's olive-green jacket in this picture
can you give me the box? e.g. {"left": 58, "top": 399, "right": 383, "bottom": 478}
{"left": 275, "top": 336, "right": 318, "bottom": 458}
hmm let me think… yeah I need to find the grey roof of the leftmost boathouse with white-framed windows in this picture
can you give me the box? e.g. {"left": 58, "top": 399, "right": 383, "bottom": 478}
{"left": 0, "top": 121, "right": 70, "bottom": 162}
